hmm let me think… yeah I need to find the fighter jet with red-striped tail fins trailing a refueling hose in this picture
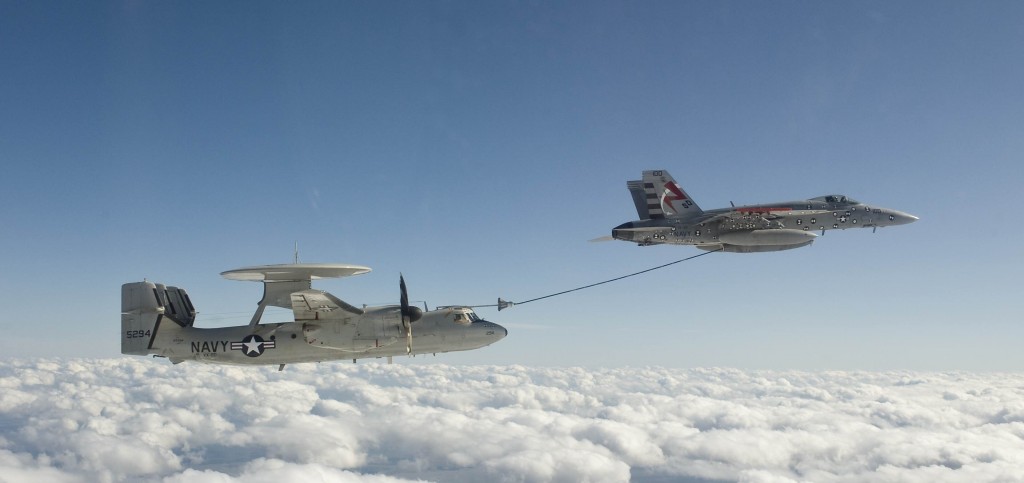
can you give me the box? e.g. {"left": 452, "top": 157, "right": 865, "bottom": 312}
{"left": 611, "top": 170, "right": 918, "bottom": 253}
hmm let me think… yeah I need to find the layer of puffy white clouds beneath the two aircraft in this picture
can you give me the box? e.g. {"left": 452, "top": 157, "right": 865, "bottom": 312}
{"left": 0, "top": 358, "right": 1024, "bottom": 483}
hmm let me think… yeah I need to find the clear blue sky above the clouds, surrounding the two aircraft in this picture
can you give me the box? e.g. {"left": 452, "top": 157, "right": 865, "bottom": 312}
{"left": 0, "top": 2, "right": 1024, "bottom": 370}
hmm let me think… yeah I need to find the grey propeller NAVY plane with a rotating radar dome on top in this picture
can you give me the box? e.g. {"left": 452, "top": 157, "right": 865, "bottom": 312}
{"left": 121, "top": 264, "right": 508, "bottom": 369}
